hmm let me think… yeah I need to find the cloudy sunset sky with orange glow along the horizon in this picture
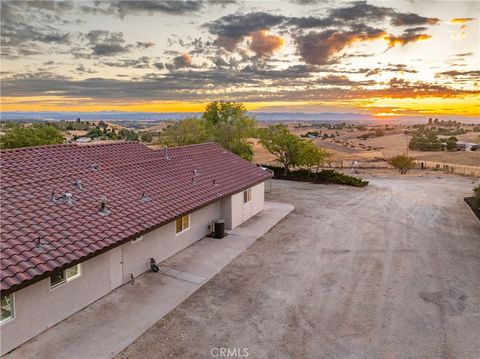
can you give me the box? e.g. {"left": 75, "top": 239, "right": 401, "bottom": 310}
{"left": 1, "top": 0, "right": 480, "bottom": 116}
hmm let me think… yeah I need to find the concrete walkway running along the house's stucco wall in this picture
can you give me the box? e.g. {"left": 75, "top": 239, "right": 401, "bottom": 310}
{"left": 3, "top": 202, "right": 294, "bottom": 359}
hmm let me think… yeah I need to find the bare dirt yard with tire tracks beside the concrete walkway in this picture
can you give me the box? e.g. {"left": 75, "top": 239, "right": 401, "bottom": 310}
{"left": 118, "top": 172, "right": 480, "bottom": 359}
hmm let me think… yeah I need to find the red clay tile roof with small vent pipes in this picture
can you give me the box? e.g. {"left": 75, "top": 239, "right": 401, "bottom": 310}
{"left": 0, "top": 142, "right": 270, "bottom": 292}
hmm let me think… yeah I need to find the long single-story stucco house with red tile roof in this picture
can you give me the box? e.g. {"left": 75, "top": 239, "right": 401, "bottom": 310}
{"left": 0, "top": 142, "right": 270, "bottom": 355}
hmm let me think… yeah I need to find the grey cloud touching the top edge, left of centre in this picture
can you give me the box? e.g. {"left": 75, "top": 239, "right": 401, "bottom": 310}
{"left": 80, "top": 0, "right": 204, "bottom": 19}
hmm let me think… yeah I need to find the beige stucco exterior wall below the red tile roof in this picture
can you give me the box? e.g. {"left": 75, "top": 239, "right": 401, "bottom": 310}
{"left": 0, "top": 183, "right": 264, "bottom": 355}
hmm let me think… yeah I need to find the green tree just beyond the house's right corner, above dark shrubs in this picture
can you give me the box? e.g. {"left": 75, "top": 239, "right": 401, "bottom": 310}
{"left": 258, "top": 124, "right": 329, "bottom": 176}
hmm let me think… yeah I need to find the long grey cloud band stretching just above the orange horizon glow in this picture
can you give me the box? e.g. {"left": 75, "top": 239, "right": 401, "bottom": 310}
{"left": 1, "top": 69, "right": 480, "bottom": 102}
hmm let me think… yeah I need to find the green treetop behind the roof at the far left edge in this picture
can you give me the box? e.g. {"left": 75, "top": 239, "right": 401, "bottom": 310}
{"left": 0, "top": 124, "right": 63, "bottom": 149}
